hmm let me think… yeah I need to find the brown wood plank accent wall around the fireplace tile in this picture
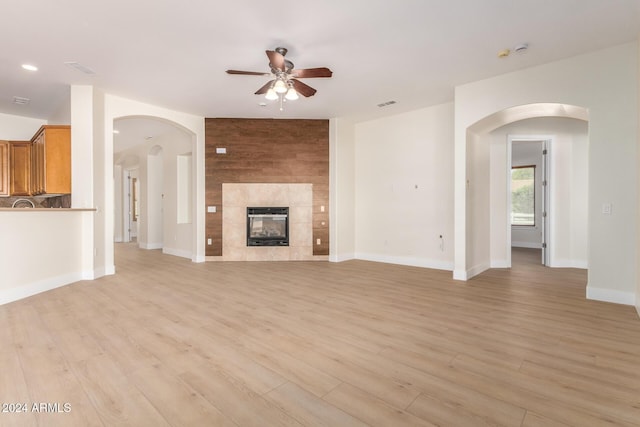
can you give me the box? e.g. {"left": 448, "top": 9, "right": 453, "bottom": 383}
{"left": 204, "top": 118, "right": 329, "bottom": 256}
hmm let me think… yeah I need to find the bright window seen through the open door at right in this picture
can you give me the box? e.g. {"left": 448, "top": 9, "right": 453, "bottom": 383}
{"left": 511, "top": 166, "right": 536, "bottom": 226}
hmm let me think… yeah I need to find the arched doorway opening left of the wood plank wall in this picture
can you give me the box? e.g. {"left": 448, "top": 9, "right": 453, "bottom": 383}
{"left": 114, "top": 116, "right": 196, "bottom": 259}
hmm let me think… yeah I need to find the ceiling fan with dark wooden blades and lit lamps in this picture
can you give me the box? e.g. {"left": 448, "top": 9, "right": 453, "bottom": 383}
{"left": 227, "top": 47, "right": 333, "bottom": 110}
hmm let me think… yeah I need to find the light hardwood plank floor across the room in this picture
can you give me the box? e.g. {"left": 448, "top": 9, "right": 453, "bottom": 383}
{"left": 0, "top": 244, "right": 640, "bottom": 427}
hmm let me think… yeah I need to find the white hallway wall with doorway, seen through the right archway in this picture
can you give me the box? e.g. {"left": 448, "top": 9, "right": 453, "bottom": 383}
{"left": 490, "top": 117, "right": 588, "bottom": 268}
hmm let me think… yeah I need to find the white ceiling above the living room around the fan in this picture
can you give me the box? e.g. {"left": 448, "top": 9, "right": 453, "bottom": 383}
{"left": 0, "top": 0, "right": 640, "bottom": 145}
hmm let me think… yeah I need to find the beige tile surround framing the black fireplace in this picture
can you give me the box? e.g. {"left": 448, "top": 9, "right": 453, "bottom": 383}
{"left": 216, "top": 184, "right": 328, "bottom": 261}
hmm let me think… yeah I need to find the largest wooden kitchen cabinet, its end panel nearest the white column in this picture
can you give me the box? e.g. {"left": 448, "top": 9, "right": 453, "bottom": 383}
{"left": 31, "top": 125, "right": 71, "bottom": 196}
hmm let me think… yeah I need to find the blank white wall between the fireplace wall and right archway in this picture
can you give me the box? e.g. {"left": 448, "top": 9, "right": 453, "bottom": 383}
{"left": 355, "top": 104, "right": 453, "bottom": 270}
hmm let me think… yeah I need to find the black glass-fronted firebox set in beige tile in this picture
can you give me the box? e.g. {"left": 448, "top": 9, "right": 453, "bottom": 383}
{"left": 247, "top": 207, "right": 289, "bottom": 246}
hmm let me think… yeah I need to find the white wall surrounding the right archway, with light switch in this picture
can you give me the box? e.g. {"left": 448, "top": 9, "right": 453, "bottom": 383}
{"left": 455, "top": 43, "right": 638, "bottom": 304}
